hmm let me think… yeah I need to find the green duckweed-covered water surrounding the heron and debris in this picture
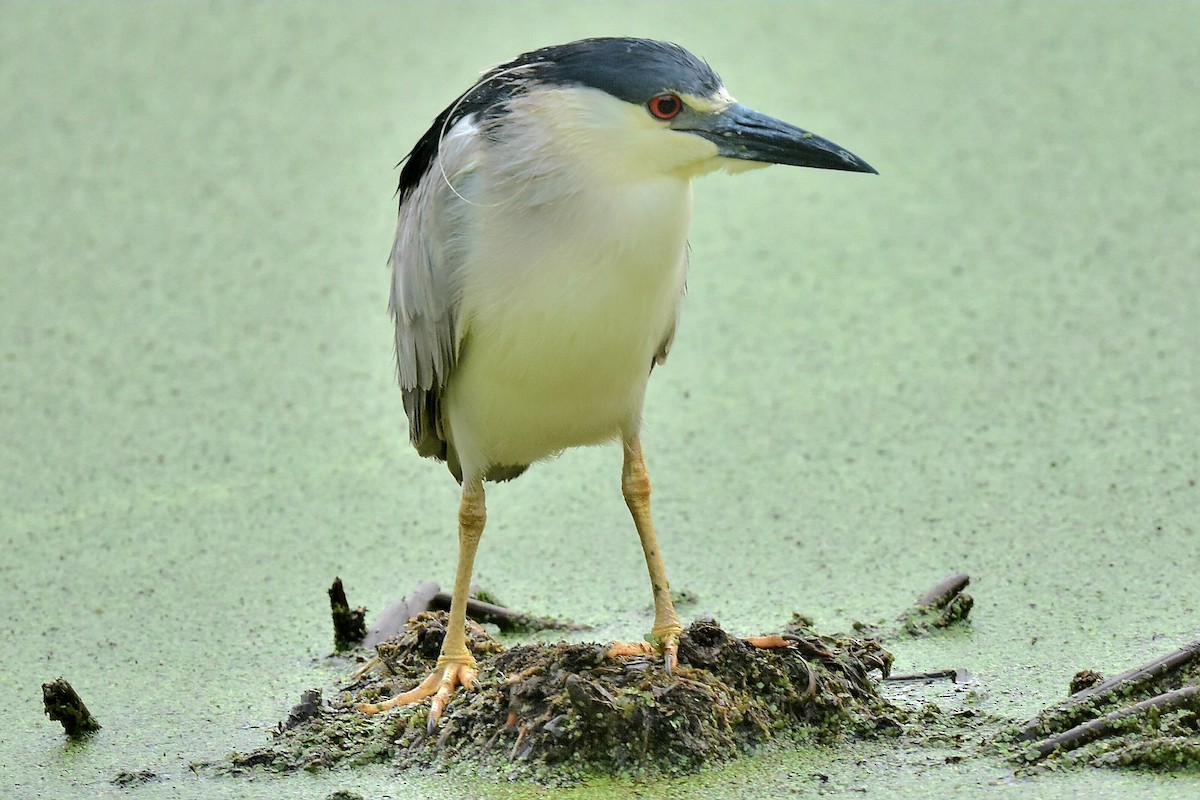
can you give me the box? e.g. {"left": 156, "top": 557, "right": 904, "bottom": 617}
{"left": 0, "top": 2, "right": 1200, "bottom": 799}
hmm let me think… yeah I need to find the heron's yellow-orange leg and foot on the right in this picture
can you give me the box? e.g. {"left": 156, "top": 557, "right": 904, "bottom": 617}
{"left": 608, "top": 437, "right": 683, "bottom": 672}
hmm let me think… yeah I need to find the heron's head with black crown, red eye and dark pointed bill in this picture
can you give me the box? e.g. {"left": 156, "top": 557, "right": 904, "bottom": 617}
{"left": 462, "top": 38, "right": 876, "bottom": 180}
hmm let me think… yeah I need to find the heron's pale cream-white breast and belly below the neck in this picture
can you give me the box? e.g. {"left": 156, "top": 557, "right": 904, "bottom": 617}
{"left": 444, "top": 176, "right": 691, "bottom": 474}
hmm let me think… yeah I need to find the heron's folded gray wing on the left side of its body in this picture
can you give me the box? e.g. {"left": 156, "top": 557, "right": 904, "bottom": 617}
{"left": 389, "top": 119, "right": 479, "bottom": 472}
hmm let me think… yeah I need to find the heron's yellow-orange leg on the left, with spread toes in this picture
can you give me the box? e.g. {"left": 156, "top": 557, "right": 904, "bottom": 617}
{"left": 358, "top": 479, "right": 487, "bottom": 730}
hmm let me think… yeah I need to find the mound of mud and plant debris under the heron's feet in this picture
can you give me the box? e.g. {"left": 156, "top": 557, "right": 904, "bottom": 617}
{"left": 232, "top": 613, "right": 901, "bottom": 783}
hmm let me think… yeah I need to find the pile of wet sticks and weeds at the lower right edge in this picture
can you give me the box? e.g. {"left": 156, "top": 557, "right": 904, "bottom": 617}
{"left": 996, "top": 642, "right": 1200, "bottom": 770}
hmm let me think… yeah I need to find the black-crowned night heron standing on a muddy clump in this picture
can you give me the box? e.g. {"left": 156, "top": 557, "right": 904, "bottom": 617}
{"left": 360, "top": 38, "right": 875, "bottom": 728}
